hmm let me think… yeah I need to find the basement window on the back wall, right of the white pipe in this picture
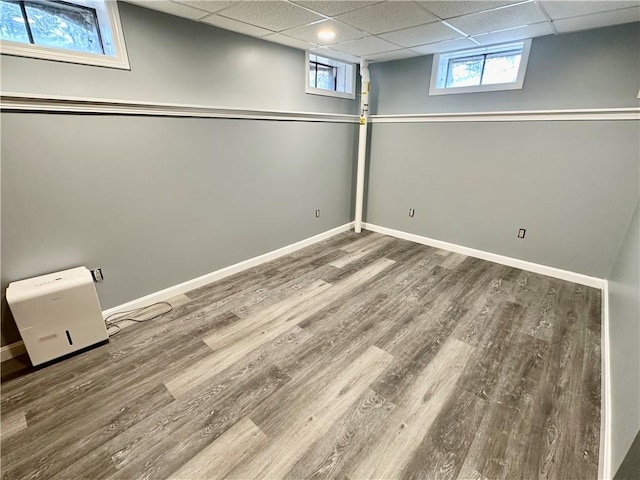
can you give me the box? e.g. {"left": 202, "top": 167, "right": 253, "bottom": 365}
{"left": 429, "top": 40, "right": 531, "bottom": 95}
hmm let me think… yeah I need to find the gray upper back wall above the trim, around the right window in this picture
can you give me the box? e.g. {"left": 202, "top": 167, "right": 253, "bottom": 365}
{"left": 370, "top": 23, "right": 640, "bottom": 115}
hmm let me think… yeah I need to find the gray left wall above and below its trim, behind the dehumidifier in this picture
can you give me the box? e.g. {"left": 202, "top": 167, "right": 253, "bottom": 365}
{"left": 1, "top": 0, "right": 357, "bottom": 345}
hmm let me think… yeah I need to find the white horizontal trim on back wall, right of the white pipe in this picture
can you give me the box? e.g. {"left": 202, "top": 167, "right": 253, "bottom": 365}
{"left": 371, "top": 107, "right": 640, "bottom": 123}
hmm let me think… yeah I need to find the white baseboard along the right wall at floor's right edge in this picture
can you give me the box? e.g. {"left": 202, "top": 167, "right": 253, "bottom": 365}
{"left": 598, "top": 280, "right": 613, "bottom": 480}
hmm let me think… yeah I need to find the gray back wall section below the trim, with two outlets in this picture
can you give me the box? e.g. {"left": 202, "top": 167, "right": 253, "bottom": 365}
{"left": 366, "top": 122, "right": 640, "bottom": 278}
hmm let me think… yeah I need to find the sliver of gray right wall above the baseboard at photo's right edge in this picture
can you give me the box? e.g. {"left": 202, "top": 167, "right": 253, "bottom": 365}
{"left": 609, "top": 202, "right": 640, "bottom": 473}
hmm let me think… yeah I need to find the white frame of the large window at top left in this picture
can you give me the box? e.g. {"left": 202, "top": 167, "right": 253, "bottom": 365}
{"left": 0, "top": 0, "right": 131, "bottom": 70}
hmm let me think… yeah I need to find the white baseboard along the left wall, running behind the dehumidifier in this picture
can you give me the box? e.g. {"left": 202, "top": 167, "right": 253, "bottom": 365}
{"left": 0, "top": 222, "right": 354, "bottom": 362}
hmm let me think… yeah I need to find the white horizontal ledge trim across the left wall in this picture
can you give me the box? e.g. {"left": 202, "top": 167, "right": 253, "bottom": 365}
{"left": 0, "top": 92, "right": 359, "bottom": 123}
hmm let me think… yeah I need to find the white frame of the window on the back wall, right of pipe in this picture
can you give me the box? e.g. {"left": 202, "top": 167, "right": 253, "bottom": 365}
{"left": 429, "top": 39, "right": 531, "bottom": 95}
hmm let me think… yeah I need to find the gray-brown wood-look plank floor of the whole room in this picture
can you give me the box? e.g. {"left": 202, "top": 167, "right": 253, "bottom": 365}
{"left": 0, "top": 232, "right": 601, "bottom": 480}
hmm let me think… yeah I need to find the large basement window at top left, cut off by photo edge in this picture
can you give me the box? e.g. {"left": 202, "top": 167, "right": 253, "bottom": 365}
{"left": 0, "top": 0, "right": 129, "bottom": 69}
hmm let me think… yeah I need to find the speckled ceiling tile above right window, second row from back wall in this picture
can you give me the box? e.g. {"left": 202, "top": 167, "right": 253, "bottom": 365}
{"left": 447, "top": 3, "right": 546, "bottom": 35}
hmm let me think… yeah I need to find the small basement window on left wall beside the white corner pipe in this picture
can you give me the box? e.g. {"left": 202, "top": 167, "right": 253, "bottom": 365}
{"left": 305, "top": 52, "right": 356, "bottom": 98}
